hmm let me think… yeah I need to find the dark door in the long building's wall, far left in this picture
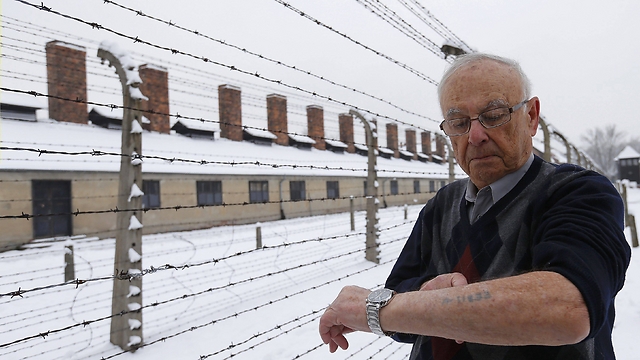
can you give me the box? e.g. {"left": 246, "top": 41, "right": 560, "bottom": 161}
{"left": 31, "top": 180, "right": 71, "bottom": 238}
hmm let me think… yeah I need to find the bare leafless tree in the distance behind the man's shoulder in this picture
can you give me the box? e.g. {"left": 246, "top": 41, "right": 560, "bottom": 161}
{"left": 582, "top": 124, "right": 637, "bottom": 180}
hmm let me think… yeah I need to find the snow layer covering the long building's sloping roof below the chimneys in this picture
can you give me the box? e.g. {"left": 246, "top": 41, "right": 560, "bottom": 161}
{"left": 0, "top": 120, "right": 452, "bottom": 179}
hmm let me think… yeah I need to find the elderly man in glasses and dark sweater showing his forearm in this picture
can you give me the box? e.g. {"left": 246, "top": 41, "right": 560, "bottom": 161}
{"left": 320, "top": 54, "right": 630, "bottom": 359}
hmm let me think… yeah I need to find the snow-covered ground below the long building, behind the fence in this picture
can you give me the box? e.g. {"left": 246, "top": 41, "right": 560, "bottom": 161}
{"left": 0, "top": 188, "right": 640, "bottom": 360}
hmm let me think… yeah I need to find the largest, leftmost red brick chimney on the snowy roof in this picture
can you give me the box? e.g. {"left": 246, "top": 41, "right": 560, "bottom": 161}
{"left": 46, "top": 40, "right": 89, "bottom": 124}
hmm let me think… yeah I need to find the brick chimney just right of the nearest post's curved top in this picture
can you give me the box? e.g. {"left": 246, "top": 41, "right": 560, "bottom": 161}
{"left": 138, "top": 64, "right": 171, "bottom": 134}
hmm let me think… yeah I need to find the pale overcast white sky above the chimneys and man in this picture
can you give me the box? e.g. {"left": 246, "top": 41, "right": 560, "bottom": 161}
{"left": 2, "top": 0, "right": 640, "bottom": 148}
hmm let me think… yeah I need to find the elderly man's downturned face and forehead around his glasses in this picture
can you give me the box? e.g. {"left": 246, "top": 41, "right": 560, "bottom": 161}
{"left": 440, "top": 60, "right": 540, "bottom": 189}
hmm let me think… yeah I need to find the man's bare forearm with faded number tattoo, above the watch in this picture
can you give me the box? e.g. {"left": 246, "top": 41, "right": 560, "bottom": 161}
{"left": 380, "top": 271, "right": 589, "bottom": 345}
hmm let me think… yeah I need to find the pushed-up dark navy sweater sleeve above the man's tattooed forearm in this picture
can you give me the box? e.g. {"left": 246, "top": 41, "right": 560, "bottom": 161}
{"left": 532, "top": 167, "right": 631, "bottom": 338}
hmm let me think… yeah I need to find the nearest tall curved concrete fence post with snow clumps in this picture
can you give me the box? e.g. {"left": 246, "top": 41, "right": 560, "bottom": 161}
{"left": 98, "top": 42, "right": 148, "bottom": 352}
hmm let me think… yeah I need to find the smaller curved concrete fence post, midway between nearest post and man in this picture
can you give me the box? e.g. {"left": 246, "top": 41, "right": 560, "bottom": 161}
{"left": 349, "top": 110, "right": 380, "bottom": 264}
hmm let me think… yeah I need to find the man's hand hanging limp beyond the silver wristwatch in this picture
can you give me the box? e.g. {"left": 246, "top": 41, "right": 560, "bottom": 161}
{"left": 320, "top": 286, "right": 371, "bottom": 353}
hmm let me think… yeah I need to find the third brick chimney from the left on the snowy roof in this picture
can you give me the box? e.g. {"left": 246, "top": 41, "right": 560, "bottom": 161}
{"left": 218, "top": 84, "right": 242, "bottom": 141}
